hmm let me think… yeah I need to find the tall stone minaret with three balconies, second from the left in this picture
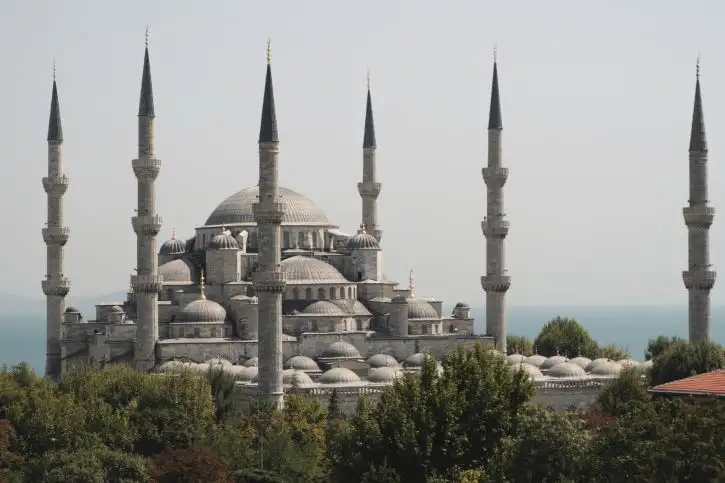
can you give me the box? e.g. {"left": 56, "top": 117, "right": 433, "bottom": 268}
{"left": 131, "top": 32, "right": 162, "bottom": 371}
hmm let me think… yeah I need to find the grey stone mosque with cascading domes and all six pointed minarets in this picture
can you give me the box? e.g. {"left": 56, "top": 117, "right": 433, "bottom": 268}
{"left": 42, "top": 36, "right": 715, "bottom": 411}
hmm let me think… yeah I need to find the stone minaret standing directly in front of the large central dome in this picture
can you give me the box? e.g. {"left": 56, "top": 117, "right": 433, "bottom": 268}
{"left": 252, "top": 43, "right": 285, "bottom": 407}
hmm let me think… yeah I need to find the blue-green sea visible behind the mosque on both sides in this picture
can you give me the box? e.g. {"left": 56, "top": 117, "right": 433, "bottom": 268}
{"left": 0, "top": 306, "right": 725, "bottom": 372}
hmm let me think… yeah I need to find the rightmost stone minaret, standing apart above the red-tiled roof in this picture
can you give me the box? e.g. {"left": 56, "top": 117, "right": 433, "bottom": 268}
{"left": 682, "top": 59, "right": 715, "bottom": 342}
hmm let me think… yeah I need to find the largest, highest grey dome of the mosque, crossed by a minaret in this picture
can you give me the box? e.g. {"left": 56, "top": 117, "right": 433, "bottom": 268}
{"left": 204, "top": 186, "right": 330, "bottom": 226}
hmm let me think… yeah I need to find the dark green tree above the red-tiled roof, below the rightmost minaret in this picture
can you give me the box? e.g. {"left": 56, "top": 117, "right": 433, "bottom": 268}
{"left": 651, "top": 341, "right": 725, "bottom": 386}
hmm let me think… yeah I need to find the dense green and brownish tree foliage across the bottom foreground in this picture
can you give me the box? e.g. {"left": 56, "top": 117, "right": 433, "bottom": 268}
{"left": 0, "top": 339, "right": 725, "bottom": 483}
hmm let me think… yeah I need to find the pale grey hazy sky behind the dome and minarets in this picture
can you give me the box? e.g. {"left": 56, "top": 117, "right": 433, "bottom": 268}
{"left": 0, "top": 0, "right": 725, "bottom": 306}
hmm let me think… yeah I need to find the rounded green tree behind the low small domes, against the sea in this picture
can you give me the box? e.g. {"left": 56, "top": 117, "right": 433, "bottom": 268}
{"left": 534, "top": 317, "right": 597, "bottom": 358}
